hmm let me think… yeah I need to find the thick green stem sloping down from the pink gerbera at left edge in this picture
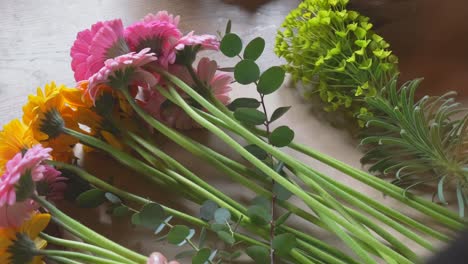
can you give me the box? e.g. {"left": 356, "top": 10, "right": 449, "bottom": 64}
{"left": 33, "top": 196, "right": 147, "bottom": 263}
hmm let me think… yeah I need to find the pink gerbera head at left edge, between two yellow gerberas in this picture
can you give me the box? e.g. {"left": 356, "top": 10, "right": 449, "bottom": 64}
{"left": 0, "top": 144, "right": 52, "bottom": 208}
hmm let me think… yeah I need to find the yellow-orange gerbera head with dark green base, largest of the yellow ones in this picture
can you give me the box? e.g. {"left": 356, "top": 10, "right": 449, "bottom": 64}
{"left": 23, "top": 82, "right": 79, "bottom": 162}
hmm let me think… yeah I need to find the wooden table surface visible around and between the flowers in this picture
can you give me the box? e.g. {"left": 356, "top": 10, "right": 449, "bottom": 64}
{"left": 0, "top": 0, "right": 468, "bottom": 262}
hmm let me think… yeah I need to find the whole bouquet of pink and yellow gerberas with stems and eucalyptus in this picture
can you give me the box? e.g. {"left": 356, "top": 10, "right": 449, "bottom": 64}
{"left": 0, "top": 8, "right": 465, "bottom": 264}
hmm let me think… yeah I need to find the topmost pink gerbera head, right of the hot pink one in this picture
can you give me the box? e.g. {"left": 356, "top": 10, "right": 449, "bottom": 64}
{"left": 125, "top": 11, "right": 182, "bottom": 68}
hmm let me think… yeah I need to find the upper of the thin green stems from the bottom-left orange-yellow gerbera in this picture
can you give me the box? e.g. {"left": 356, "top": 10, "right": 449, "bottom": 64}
{"left": 40, "top": 233, "right": 138, "bottom": 264}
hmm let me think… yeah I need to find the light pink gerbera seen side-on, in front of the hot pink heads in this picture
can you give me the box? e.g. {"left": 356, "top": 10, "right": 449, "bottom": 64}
{"left": 87, "top": 48, "right": 158, "bottom": 101}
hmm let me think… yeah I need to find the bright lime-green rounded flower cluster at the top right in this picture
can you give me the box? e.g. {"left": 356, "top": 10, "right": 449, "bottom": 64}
{"left": 275, "top": 0, "right": 398, "bottom": 126}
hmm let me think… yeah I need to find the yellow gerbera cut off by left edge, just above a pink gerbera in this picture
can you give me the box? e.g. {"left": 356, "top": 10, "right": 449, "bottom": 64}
{"left": 0, "top": 119, "right": 38, "bottom": 173}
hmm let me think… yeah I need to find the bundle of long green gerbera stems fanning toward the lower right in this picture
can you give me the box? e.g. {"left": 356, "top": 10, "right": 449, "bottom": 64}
{"left": 44, "top": 65, "right": 465, "bottom": 263}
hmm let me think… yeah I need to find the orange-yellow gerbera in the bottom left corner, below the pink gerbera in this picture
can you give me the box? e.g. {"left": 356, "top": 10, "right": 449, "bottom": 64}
{"left": 0, "top": 214, "right": 51, "bottom": 264}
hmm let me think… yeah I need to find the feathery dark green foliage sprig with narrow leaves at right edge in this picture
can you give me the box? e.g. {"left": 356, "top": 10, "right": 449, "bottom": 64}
{"left": 361, "top": 79, "right": 468, "bottom": 216}
